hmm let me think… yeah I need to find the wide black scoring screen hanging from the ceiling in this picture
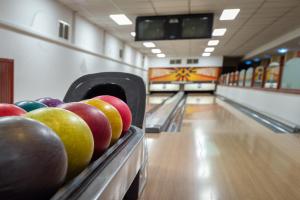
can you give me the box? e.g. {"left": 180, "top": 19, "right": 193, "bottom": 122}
{"left": 135, "top": 13, "right": 213, "bottom": 41}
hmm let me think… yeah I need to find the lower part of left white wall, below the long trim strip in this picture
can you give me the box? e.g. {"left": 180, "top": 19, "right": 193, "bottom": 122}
{"left": 0, "top": 26, "right": 145, "bottom": 101}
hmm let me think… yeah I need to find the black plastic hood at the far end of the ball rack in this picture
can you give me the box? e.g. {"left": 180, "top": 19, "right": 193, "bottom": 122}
{"left": 64, "top": 72, "right": 146, "bottom": 128}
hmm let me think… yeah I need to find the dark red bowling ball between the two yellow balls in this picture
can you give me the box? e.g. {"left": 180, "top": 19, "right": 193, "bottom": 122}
{"left": 58, "top": 102, "right": 112, "bottom": 158}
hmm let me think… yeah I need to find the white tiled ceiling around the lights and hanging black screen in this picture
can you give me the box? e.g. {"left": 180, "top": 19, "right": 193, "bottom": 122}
{"left": 59, "top": 0, "right": 300, "bottom": 57}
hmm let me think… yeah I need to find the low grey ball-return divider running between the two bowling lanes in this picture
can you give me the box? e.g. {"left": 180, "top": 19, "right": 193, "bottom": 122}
{"left": 146, "top": 91, "right": 185, "bottom": 133}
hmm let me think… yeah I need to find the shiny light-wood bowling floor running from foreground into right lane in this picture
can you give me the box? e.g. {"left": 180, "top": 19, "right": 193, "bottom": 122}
{"left": 141, "top": 96, "right": 300, "bottom": 200}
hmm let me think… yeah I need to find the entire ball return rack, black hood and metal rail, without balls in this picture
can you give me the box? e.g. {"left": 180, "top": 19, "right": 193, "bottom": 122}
{"left": 51, "top": 72, "right": 148, "bottom": 200}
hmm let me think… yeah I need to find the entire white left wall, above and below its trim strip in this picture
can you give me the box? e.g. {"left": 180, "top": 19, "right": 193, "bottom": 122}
{"left": 0, "top": 0, "right": 147, "bottom": 101}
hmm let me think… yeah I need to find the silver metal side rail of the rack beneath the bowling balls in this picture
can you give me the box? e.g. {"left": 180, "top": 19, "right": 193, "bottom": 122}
{"left": 51, "top": 126, "right": 144, "bottom": 200}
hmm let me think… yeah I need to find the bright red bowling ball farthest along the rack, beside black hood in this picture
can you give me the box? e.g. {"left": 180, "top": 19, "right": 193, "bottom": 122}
{"left": 95, "top": 95, "right": 132, "bottom": 134}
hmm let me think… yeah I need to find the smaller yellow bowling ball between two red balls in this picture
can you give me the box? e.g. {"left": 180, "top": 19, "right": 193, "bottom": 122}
{"left": 83, "top": 99, "right": 123, "bottom": 145}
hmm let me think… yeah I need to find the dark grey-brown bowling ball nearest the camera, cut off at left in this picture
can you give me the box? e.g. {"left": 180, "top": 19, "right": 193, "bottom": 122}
{"left": 0, "top": 116, "right": 68, "bottom": 200}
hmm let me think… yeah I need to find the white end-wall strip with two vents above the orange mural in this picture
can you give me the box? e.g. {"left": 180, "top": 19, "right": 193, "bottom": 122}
{"left": 148, "top": 56, "right": 223, "bottom": 67}
